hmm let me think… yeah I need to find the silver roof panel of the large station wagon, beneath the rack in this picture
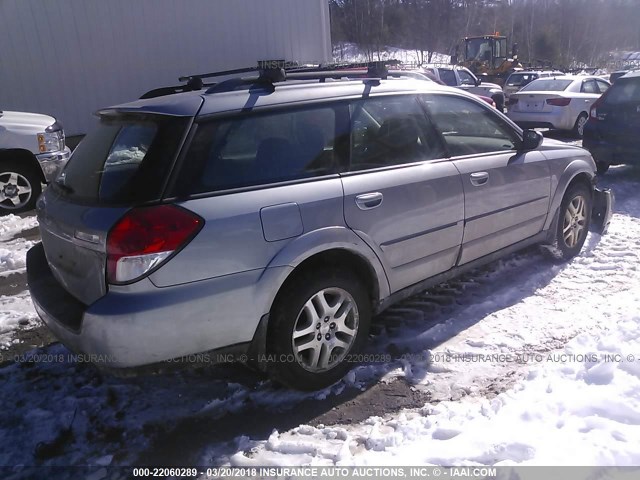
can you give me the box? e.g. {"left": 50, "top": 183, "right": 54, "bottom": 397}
{"left": 101, "top": 78, "right": 462, "bottom": 116}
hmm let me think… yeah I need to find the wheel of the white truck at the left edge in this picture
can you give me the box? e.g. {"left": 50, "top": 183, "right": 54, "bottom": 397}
{"left": 0, "top": 160, "right": 42, "bottom": 215}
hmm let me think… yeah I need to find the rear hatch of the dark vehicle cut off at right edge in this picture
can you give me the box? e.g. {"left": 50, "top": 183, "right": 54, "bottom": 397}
{"left": 595, "top": 76, "right": 640, "bottom": 149}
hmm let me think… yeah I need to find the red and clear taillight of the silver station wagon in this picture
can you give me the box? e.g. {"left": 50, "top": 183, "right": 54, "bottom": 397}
{"left": 107, "top": 205, "right": 204, "bottom": 283}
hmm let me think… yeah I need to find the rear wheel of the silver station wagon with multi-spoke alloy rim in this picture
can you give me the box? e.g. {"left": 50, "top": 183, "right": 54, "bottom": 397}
{"left": 267, "top": 268, "right": 371, "bottom": 390}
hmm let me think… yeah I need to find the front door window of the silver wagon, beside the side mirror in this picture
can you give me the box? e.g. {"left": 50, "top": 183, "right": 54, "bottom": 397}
{"left": 422, "top": 94, "right": 521, "bottom": 157}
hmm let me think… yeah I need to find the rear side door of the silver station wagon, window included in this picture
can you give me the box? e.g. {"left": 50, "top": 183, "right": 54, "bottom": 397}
{"left": 342, "top": 95, "right": 464, "bottom": 291}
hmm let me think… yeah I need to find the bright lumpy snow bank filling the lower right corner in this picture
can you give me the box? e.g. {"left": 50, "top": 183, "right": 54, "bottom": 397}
{"left": 230, "top": 304, "right": 640, "bottom": 466}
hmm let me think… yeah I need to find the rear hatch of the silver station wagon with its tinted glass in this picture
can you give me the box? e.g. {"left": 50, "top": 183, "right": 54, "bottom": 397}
{"left": 38, "top": 110, "right": 189, "bottom": 305}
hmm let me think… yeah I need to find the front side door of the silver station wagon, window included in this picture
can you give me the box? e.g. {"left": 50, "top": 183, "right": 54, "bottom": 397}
{"left": 423, "top": 94, "right": 551, "bottom": 264}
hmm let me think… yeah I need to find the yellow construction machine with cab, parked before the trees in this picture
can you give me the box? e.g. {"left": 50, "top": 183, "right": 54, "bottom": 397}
{"left": 451, "top": 32, "right": 522, "bottom": 86}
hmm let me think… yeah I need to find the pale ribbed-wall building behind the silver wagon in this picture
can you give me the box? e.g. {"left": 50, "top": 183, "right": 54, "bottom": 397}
{"left": 0, "top": 0, "right": 331, "bottom": 135}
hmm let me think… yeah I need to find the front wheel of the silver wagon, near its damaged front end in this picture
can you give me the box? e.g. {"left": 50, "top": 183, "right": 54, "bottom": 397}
{"left": 552, "top": 184, "right": 593, "bottom": 261}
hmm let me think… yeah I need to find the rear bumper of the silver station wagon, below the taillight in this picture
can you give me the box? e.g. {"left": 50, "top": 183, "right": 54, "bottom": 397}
{"left": 27, "top": 244, "right": 284, "bottom": 369}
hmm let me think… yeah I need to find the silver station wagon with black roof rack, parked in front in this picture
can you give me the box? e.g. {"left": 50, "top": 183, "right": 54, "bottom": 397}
{"left": 27, "top": 62, "right": 612, "bottom": 390}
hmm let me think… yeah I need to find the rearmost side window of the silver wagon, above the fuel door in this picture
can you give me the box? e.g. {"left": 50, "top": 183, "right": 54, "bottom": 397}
{"left": 172, "top": 104, "right": 348, "bottom": 194}
